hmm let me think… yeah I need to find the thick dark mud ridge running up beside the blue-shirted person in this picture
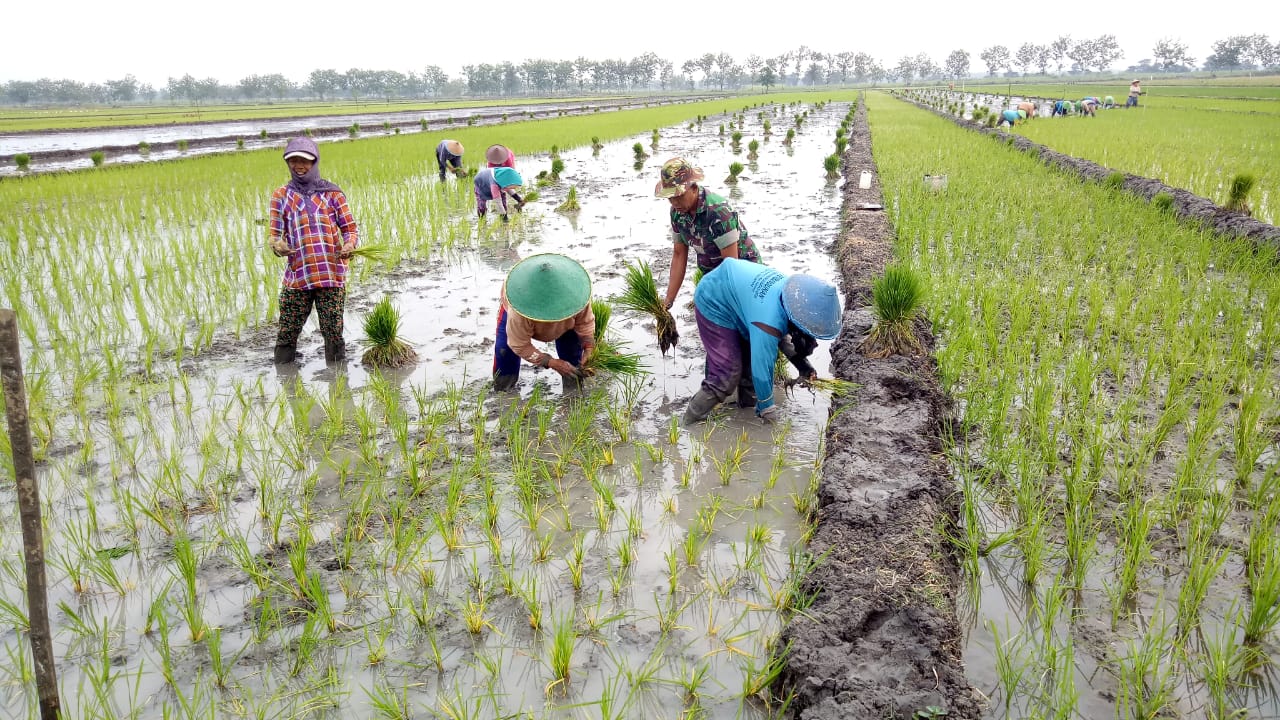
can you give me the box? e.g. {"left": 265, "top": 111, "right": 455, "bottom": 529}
{"left": 780, "top": 95, "right": 980, "bottom": 720}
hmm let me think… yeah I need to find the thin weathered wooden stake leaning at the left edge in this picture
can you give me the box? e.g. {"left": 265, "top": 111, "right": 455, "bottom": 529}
{"left": 0, "top": 309, "right": 59, "bottom": 720}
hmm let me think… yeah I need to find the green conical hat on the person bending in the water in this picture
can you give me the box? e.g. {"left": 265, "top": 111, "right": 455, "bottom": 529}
{"left": 507, "top": 252, "right": 591, "bottom": 323}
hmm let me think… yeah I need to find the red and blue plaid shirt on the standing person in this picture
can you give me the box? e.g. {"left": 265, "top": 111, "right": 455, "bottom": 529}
{"left": 268, "top": 184, "right": 360, "bottom": 290}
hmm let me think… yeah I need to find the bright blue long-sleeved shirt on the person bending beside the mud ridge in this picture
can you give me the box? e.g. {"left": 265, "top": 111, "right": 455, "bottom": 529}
{"left": 694, "top": 258, "right": 787, "bottom": 413}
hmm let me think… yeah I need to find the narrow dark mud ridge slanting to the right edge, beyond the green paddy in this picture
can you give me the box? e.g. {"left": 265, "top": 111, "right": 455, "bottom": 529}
{"left": 892, "top": 94, "right": 1280, "bottom": 247}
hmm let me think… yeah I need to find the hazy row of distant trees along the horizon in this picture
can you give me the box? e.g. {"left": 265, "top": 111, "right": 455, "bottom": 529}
{"left": 0, "top": 35, "right": 1280, "bottom": 105}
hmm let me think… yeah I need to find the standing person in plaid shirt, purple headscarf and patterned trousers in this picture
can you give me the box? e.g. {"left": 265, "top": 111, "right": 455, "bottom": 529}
{"left": 268, "top": 137, "right": 360, "bottom": 363}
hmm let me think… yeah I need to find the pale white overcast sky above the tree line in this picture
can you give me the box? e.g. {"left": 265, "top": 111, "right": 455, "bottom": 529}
{"left": 0, "top": 0, "right": 1280, "bottom": 87}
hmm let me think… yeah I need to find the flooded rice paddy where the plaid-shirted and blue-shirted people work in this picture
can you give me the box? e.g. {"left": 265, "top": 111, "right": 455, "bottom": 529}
{"left": 0, "top": 94, "right": 852, "bottom": 719}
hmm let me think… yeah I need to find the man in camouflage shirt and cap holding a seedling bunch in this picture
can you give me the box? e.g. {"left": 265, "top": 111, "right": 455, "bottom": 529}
{"left": 654, "top": 158, "right": 760, "bottom": 307}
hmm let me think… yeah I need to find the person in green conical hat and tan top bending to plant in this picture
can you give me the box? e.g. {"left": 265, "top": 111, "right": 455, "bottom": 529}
{"left": 493, "top": 252, "right": 595, "bottom": 391}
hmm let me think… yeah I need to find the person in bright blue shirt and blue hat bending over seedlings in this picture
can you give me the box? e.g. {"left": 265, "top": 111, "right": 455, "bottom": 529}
{"left": 685, "top": 258, "right": 841, "bottom": 424}
